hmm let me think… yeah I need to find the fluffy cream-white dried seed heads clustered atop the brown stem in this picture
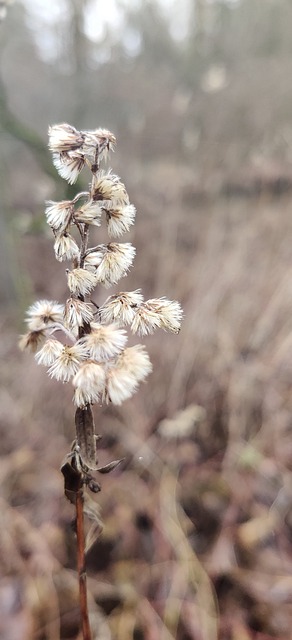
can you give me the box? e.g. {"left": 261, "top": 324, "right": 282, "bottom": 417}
{"left": 20, "top": 124, "right": 182, "bottom": 408}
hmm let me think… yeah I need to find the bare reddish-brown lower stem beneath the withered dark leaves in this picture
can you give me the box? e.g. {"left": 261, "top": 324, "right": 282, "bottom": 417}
{"left": 76, "top": 486, "right": 92, "bottom": 640}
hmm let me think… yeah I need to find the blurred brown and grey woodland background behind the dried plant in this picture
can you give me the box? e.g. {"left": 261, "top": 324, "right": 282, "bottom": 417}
{"left": 0, "top": 0, "right": 292, "bottom": 640}
